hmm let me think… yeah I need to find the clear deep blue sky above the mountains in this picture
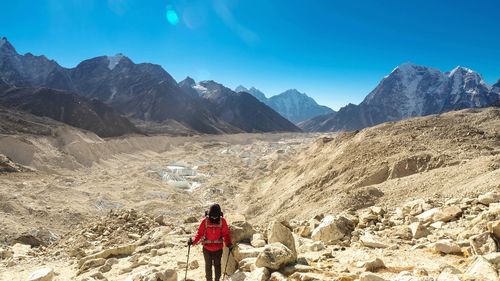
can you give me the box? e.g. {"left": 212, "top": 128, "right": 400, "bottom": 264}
{"left": 0, "top": 0, "right": 500, "bottom": 109}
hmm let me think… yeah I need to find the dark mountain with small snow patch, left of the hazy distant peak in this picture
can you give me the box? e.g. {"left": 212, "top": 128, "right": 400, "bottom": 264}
{"left": 188, "top": 81, "right": 300, "bottom": 132}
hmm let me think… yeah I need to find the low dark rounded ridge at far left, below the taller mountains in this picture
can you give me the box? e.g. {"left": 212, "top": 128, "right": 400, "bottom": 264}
{"left": 0, "top": 88, "right": 139, "bottom": 137}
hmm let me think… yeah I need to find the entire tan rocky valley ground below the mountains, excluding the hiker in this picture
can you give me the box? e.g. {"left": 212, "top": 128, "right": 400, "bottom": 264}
{"left": 0, "top": 109, "right": 500, "bottom": 281}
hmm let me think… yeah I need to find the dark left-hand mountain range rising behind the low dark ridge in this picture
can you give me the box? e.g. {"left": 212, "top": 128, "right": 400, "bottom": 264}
{"left": 0, "top": 38, "right": 300, "bottom": 134}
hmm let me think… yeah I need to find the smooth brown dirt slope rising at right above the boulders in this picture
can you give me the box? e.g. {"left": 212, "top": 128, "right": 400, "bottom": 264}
{"left": 248, "top": 108, "right": 500, "bottom": 220}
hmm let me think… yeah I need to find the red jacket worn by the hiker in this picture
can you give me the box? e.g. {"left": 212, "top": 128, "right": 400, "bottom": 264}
{"left": 193, "top": 215, "right": 231, "bottom": 252}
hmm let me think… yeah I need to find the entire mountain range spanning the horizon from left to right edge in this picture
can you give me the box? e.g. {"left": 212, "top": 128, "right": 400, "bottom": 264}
{"left": 0, "top": 38, "right": 500, "bottom": 137}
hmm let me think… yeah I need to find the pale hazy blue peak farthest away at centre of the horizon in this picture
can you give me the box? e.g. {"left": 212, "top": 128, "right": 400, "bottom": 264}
{"left": 235, "top": 86, "right": 334, "bottom": 123}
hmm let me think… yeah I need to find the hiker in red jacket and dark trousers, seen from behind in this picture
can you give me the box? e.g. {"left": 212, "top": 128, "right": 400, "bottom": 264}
{"left": 188, "top": 204, "right": 233, "bottom": 281}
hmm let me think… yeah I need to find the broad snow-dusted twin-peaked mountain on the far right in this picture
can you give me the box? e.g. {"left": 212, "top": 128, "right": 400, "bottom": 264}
{"left": 299, "top": 63, "right": 499, "bottom": 131}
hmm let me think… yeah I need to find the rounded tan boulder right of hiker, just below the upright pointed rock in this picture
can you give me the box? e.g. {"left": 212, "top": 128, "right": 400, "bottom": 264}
{"left": 255, "top": 243, "right": 297, "bottom": 270}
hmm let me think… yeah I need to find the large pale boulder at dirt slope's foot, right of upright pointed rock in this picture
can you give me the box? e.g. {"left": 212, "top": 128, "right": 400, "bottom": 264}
{"left": 311, "top": 216, "right": 355, "bottom": 244}
